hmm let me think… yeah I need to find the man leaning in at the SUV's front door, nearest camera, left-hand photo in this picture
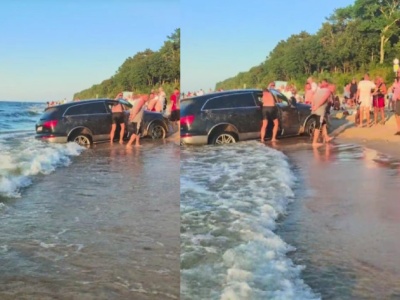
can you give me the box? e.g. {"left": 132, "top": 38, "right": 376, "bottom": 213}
{"left": 126, "top": 95, "right": 148, "bottom": 148}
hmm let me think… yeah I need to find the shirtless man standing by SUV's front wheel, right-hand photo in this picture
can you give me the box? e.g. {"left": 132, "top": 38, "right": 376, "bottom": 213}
{"left": 311, "top": 79, "right": 334, "bottom": 146}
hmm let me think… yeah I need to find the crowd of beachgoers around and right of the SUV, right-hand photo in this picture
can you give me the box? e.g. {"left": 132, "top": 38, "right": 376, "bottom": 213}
{"left": 260, "top": 72, "right": 400, "bottom": 146}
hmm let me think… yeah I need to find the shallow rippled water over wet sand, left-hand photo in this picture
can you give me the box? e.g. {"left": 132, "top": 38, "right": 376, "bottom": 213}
{"left": 0, "top": 140, "right": 180, "bottom": 300}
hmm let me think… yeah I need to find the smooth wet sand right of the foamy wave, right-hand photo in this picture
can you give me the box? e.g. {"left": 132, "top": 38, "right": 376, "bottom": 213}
{"left": 276, "top": 138, "right": 400, "bottom": 299}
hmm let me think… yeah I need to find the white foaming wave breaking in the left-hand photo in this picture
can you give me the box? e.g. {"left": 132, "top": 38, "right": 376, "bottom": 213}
{"left": 0, "top": 138, "right": 85, "bottom": 198}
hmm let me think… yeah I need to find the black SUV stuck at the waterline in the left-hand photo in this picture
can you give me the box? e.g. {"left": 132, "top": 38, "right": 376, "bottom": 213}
{"left": 35, "top": 99, "right": 169, "bottom": 146}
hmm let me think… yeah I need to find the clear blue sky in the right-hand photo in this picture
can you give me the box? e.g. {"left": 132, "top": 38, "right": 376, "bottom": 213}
{"left": 181, "top": 0, "right": 354, "bottom": 92}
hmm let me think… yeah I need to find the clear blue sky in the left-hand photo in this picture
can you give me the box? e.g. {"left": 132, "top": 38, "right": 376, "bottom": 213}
{"left": 0, "top": 0, "right": 181, "bottom": 101}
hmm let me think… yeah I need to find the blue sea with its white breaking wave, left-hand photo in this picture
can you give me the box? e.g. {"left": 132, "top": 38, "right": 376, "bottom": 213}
{"left": 0, "top": 101, "right": 85, "bottom": 199}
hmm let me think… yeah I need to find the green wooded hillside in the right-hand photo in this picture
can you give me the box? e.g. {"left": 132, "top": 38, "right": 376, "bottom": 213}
{"left": 216, "top": 0, "right": 400, "bottom": 89}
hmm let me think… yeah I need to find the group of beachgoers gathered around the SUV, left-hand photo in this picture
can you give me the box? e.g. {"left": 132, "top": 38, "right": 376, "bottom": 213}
{"left": 110, "top": 87, "right": 180, "bottom": 148}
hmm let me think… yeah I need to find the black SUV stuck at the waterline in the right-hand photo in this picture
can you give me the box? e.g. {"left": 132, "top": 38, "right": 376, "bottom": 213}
{"left": 180, "top": 89, "right": 318, "bottom": 145}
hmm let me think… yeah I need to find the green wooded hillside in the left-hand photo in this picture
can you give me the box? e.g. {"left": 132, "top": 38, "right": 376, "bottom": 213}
{"left": 74, "top": 28, "right": 180, "bottom": 99}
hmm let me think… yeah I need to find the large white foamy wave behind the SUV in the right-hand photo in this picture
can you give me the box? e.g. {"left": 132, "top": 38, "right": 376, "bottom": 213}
{"left": 181, "top": 142, "right": 318, "bottom": 299}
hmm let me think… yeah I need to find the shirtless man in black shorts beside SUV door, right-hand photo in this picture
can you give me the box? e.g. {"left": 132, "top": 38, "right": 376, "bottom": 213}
{"left": 261, "top": 88, "right": 279, "bottom": 143}
